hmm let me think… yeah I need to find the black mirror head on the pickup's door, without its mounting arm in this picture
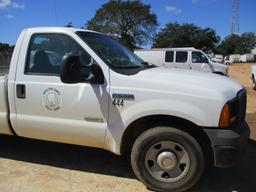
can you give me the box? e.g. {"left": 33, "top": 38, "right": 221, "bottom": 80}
{"left": 60, "top": 53, "right": 82, "bottom": 84}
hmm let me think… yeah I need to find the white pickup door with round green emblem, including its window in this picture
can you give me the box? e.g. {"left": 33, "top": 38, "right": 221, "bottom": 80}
{"left": 14, "top": 33, "right": 109, "bottom": 147}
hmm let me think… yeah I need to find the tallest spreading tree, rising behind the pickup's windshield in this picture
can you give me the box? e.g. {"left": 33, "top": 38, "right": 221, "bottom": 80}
{"left": 85, "top": 0, "right": 157, "bottom": 49}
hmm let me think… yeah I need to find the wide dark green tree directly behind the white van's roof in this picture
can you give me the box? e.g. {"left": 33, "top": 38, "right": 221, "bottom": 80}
{"left": 153, "top": 23, "right": 220, "bottom": 50}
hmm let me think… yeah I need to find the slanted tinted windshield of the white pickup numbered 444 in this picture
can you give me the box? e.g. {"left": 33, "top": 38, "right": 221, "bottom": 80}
{"left": 77, "top": 32, "right": 152, "bottom": 68}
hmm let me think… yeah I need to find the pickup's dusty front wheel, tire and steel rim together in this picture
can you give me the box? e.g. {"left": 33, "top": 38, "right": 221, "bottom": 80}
{"left": 131, "top": 127, "right": 205, "bottom": 192}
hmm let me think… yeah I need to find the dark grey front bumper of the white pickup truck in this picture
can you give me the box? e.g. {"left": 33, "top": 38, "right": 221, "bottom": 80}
{"left": 204, "top": 122, "right": 250, "bottom": 167}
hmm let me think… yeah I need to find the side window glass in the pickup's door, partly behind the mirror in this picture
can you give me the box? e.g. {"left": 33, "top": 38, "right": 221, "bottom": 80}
{"left": 25, "top": 34, "right": 91, "bottom": 77}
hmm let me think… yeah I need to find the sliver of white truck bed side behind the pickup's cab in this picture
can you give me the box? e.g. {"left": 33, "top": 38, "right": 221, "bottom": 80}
{"left": 0, "top": 75, "right": 12, "bottom": 135}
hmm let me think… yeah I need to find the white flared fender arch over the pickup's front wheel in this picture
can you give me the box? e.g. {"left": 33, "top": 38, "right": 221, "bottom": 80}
{"left": 105, "top": 99, "right": 220, "bottom": 154}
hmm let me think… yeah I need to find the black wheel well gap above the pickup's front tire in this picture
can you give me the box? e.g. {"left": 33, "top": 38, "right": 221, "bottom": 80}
{"left": 121, "top": 115, "right": 214, "bottom": 166}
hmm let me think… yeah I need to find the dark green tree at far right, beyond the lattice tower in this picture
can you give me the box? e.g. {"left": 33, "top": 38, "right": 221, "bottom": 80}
{"left": 218, "top": 33, "right": 256, "bottom": 55}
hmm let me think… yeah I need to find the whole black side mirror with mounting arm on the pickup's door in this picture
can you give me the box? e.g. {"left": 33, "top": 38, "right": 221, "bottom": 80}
{"left": 60, "top": 53, "right": 104, "bottom": 84}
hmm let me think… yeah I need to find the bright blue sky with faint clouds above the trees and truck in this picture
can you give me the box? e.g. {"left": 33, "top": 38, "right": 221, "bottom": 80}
{"left": 0, "top": 0, "right": 256, "bottom": 44}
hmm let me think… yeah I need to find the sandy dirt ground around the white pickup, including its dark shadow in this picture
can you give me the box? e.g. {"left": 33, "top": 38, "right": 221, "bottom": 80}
{"left": 0, "top": 64, "right": 256, "bottom": 192}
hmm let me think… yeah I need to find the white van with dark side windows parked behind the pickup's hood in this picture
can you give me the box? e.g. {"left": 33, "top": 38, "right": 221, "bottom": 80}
{"left": 134, "top": 48, "right": 228, "bottom": 75}
